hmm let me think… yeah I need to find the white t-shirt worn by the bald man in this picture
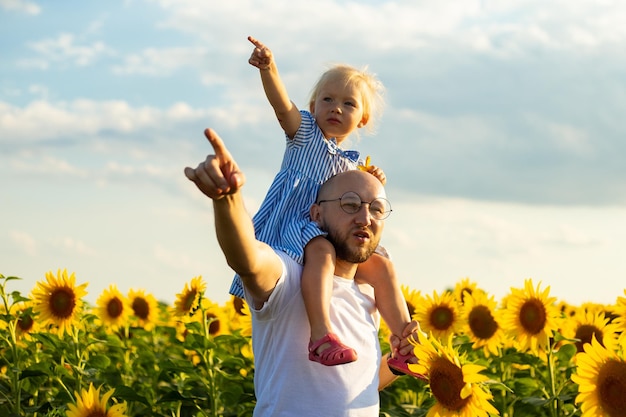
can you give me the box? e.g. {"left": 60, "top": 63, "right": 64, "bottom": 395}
{"left": 246, "top": 251, "right": 381, "bottom": 417}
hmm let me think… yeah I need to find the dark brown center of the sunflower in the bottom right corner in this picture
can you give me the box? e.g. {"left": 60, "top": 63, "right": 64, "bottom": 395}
{"left": 597, "top": 359, "right": 626, "bottom": 417}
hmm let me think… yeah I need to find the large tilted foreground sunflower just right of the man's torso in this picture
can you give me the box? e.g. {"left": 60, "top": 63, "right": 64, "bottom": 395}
{"left": 409, "top": 333, "right": 499, "bottom": 417}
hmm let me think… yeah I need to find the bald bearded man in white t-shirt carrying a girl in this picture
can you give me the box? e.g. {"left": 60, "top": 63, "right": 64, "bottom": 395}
{"left": 185, "top": 129, "right": 417, "bottom": 417}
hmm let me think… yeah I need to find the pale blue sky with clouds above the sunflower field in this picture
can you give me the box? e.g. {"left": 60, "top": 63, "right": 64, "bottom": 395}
{"left": 0, "top": 0, "right": 626, "bottom": 304}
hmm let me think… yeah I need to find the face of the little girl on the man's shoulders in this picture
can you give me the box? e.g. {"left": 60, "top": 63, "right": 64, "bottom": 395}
{"left": 311, "top": 80, "right": 367, "bottom": 143}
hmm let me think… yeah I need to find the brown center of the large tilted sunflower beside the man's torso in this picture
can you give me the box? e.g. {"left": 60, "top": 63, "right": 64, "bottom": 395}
{"left": 429, "top": 357, "right": 470, "bottom": 411}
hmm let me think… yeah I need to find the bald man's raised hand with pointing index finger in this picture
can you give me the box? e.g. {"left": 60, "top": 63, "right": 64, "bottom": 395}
{"left": 185, "top": 129, "right": 245, "bottom": 200}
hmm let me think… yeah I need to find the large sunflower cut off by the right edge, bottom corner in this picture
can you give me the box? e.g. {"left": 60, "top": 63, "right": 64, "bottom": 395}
{"left": 571, "top": 337, "right": 626, "bottom": 417}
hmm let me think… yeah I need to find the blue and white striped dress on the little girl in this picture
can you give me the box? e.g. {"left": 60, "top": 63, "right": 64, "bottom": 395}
{"left": 229, "top": 110, "right": 359, "bottom": 297}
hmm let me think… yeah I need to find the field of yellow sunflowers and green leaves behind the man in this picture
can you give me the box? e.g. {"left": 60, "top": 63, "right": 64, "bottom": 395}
{"left": 0, "top": 270, "right": 626, "bottom": 417}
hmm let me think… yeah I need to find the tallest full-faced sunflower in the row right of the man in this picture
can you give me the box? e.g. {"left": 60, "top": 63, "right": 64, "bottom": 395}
{"left": 501, "top": 279, "right": 559, "bottom": 353}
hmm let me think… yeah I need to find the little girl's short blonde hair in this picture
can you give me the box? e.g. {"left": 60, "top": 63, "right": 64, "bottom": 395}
{"left": 309, "top": 64, "right": 385, "bottom": 134}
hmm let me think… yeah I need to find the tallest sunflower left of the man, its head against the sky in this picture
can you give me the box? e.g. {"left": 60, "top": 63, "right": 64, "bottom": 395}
{"left": 30, "top": 269, "right": 87, "bottom": 336}
